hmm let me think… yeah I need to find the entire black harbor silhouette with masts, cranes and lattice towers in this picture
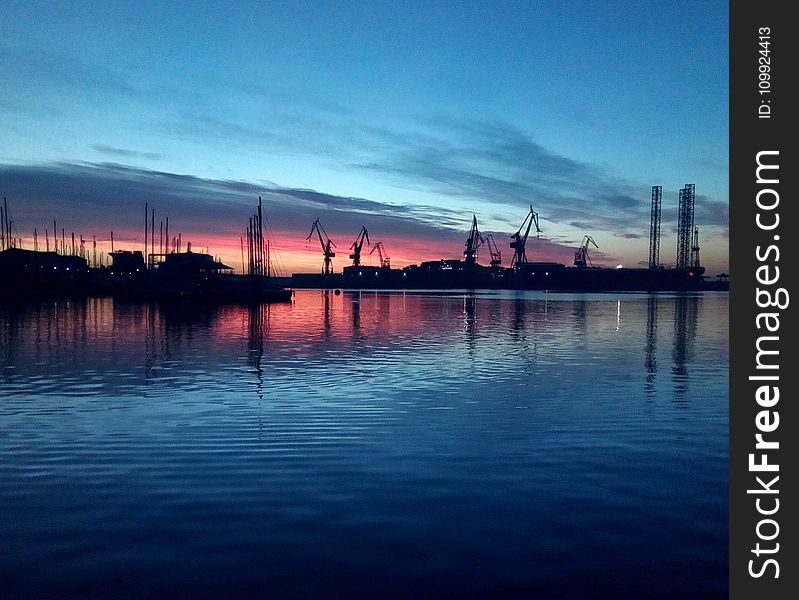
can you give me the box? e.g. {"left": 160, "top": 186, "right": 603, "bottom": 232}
{"left": 0, "top": 184, "right": 729, "bottom": 302}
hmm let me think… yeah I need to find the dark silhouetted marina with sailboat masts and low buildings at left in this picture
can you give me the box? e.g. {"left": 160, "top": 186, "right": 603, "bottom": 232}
{"left": 0, "top": 199, "right": 292, "bottom": 302}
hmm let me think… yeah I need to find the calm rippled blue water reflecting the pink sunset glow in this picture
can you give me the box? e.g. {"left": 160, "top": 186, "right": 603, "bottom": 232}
{"left": 0, "top": 291, "right": 728, "bottom": 598}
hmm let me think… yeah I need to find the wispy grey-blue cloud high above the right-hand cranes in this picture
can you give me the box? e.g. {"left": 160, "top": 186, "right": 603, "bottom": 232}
{"left": 355, "top": 119, "right": 664, "bottom": 234}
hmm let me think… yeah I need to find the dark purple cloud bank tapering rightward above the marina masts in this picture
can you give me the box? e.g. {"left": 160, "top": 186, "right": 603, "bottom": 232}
{"left": 0, "top": 163, "right": 512, "bottom": 256}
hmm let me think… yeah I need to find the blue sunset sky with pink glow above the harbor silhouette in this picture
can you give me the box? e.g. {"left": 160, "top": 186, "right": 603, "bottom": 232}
{"left": 0, "top": 0, "right": 729, "bottom": 276}
